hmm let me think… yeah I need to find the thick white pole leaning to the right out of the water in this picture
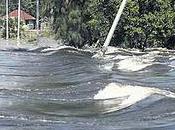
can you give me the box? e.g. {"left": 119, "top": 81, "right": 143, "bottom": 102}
{"left": 103, "top": 0, "right": 127, "bottom": 48}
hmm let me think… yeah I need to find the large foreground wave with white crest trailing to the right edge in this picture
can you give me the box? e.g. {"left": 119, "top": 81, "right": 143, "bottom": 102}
{"left": 94, "top": 83, "right": 175, "bottom": 113}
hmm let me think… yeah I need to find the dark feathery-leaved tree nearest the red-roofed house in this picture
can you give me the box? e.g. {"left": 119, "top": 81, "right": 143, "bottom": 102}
{"left": 42, "top": 0, "right": 85, "bottom": 47}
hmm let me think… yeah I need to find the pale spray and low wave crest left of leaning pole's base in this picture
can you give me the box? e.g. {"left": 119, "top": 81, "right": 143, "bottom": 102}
{"left": 0, "top": 37, "right": 95, "bottom": 55}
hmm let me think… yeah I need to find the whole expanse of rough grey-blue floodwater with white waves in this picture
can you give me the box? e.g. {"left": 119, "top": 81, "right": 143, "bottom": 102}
{"left": 0, "top": 40, "right": 175, "bottom": 130}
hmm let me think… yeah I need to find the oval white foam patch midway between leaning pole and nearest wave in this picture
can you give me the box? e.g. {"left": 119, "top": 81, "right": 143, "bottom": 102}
{"left": 117, "top": 56, "right": 153, "bottom": 71}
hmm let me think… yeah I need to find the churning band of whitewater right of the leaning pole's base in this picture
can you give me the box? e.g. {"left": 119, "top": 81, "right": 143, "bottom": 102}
{"left": 93, "top": 47, "right": 175, "bottom": 72}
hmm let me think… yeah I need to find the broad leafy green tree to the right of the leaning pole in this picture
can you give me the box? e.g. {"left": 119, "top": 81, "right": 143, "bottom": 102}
{"left": 124, "top": 0, "right": 175, "bottom": 48}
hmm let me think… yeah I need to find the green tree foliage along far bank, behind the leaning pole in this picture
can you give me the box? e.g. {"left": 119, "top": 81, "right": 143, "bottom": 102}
{"left": 0, "top": 0, "right": 175, "bottom": 48}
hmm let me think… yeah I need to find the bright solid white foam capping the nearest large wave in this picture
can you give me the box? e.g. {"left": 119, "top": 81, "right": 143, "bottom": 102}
{"left": 94, "top": 83, "right": 154, "bottom": 103}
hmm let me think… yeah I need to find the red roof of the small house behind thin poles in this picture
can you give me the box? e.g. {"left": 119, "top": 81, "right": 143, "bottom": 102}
{"left": 9, "top": 10, "right": 36, "bottom": 20}
